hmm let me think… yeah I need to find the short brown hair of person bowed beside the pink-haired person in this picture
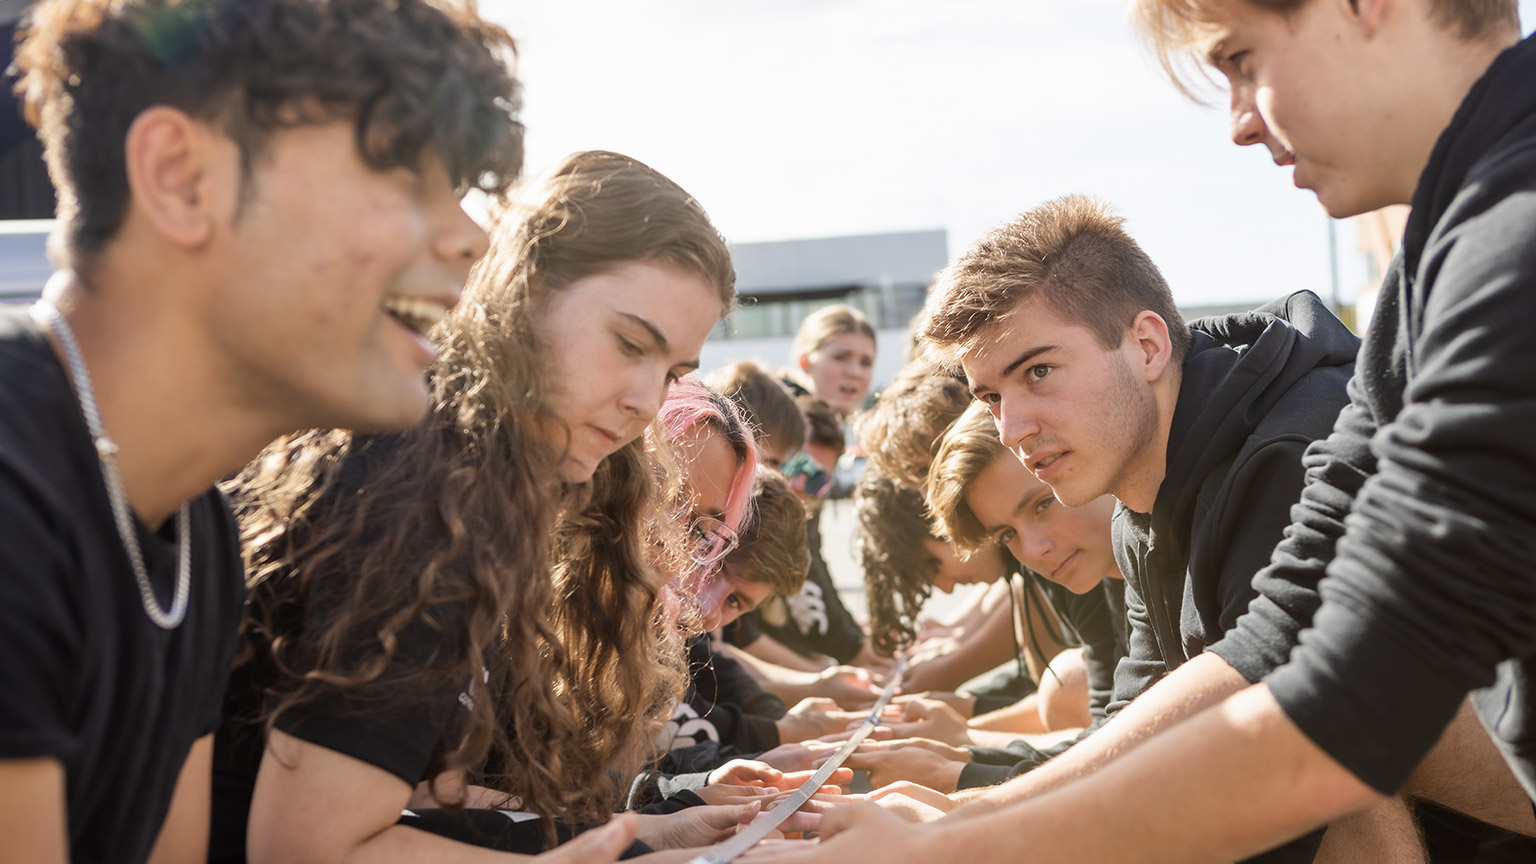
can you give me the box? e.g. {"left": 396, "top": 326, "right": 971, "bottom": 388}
{"left": 725, "top": 467, "right": 811, "bottom": 596}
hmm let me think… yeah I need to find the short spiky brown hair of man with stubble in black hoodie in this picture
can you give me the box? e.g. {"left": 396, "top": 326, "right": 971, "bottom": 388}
{"left": 920, "top": 195, "right": 1189, "bottom": 363}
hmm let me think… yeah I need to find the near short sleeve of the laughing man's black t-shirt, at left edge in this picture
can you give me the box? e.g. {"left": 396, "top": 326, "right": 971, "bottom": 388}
{"left": 0, "top": 461, "right": 83, "bottom": 759}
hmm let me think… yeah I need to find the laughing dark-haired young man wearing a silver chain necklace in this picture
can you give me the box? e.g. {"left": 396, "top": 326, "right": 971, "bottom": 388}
{"left": 0, "top": 0, "right": 633, "bottom": 862}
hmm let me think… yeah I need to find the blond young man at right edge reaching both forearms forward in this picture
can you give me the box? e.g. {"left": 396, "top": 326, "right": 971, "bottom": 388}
{"left": 749, "top": 0, "right": 1536, "bottom": 861}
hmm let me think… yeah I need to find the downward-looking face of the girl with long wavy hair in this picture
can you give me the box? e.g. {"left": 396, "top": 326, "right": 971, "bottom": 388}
{"left": 539, "top": 261, "right": 725, "bottom": 483}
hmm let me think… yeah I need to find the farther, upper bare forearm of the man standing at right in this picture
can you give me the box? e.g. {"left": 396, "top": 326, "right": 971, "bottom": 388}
{"left": 955, "top": 653, "right": 1247, "bottom": 818}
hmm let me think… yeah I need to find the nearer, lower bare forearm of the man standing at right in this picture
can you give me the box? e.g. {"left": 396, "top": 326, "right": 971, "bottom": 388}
{"left": 935, "top": 686, "right": 1379, "bottom": 864}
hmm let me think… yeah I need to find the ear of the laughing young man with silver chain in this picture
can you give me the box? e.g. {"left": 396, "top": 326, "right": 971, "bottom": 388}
{"left": 123, "top": 105, "right": 238, "bottom": 249}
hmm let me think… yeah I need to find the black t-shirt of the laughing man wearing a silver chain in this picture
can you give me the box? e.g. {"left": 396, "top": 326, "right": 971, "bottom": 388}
{"left": 0, "top": 309, "right": 244, "bottom": 864}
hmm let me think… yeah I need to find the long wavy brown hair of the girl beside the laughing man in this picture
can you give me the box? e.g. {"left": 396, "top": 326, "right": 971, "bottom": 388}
{"left": 229, "top": 152, "right": 734, "bottom": 821}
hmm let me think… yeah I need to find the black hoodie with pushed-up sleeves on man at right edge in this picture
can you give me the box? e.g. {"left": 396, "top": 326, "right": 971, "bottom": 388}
{"left": 1215, "top": 38, "right": 1536, "bottom": 796}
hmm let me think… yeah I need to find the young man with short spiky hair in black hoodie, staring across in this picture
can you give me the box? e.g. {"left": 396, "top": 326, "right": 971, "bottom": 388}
{"left": 923, "top": 195, "right": 1359, "bottom": 861}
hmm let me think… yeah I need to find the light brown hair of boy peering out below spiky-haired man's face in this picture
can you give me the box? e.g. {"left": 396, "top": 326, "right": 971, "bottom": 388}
{"left": 928, "top": 403, "right": 1014, "bottom": 558}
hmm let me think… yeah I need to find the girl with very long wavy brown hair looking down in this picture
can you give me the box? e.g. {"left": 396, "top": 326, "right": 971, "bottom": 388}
{"left": 212, "top": 152, "right": 734, "bottom": 861}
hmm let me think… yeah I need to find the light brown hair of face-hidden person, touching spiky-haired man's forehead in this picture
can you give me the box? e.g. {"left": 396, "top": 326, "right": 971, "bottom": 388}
{"left": 854, "top": 358, "right": 974, "bottom": 489}
